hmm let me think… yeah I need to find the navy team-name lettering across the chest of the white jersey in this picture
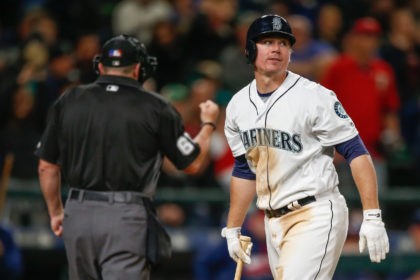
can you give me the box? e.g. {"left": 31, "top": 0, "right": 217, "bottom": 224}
{"left": 241, "top": 128, "right": 303, "bottom": 153}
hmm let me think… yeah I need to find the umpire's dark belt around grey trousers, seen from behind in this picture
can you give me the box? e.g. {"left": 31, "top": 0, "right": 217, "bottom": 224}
{"left": 68, "top": 189, "right": 146, "bottom": 204}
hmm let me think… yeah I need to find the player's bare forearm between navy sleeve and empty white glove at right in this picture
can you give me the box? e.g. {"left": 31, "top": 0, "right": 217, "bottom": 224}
{"left": 350, "top": 155, "right": 379, "bottom": 210}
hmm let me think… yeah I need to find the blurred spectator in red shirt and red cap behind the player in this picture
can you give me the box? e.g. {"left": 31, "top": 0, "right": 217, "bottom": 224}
{"left": 321, "top": 18, "right": 401, "bottom": 189}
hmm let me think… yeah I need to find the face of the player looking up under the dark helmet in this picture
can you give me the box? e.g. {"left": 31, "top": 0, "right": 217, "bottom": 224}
{"left": 255, "top": 37, "right": 292, "bottom": 75}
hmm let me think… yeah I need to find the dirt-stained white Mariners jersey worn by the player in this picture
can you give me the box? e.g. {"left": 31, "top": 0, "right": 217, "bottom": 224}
{"left": 225, "top": 71, "right": 358, "bottom": 209}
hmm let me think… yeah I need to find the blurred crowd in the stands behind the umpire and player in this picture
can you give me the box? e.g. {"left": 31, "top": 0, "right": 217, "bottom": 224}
{"left": 0, "top": 0, "right": 420, "bottom": 279}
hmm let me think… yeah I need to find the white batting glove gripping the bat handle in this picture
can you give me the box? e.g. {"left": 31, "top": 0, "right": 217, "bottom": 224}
{"left": 222, "top": 227, "right": 252, "bottom": 264}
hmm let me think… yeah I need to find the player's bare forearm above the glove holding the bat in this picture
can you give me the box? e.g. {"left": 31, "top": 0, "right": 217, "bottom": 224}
{"left": 227, "top": 177, "right": 256, "bottom": 228}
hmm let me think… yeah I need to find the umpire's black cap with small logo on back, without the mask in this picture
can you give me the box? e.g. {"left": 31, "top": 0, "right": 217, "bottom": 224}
{"left": 101, "top": 35, "right": 139, "bottom": 67}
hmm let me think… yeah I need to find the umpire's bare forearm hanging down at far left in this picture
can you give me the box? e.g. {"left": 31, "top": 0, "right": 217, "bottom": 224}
{"left": 38, "top": 160, "right": 63, "bottom": 216}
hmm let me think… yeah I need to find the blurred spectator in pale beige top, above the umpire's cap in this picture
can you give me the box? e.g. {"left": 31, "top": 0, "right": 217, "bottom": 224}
{"left": 112, "top": 0, "right": 172, "bottom": 45}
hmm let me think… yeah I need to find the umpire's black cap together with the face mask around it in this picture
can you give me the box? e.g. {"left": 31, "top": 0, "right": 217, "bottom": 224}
{"left": 93, "top": 34, "right": 157, "bottom": 83}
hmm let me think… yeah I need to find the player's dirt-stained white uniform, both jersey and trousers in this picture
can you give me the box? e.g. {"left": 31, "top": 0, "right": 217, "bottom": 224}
{"left": 225, "top": 71, "right": 358, "bottom": 279}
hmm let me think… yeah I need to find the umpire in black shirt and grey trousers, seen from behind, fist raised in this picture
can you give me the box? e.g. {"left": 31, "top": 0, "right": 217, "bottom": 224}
{"left": 35, "top": 35, "right": 219, "bottom": 280}
